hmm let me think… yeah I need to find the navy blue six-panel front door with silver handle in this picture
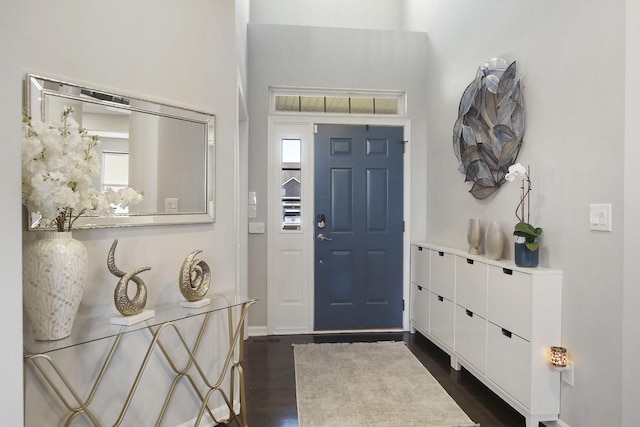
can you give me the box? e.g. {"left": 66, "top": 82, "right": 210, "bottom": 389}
{"left": 314, "top": 125, "right": 403, "bottom": 330}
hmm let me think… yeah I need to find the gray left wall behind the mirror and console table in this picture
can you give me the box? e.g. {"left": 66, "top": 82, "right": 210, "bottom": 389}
{"left": 15, "top": 0, "right": 244, "bottom": 425}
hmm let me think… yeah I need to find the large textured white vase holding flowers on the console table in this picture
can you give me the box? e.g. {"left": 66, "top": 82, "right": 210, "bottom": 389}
{"left": 22, "top": 231, "right": 87, "bottom": 340}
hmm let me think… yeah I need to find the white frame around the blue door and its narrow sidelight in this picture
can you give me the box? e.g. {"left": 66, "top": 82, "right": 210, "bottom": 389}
{"left": 266, "top": 114, "right": 411, "bottom": 335}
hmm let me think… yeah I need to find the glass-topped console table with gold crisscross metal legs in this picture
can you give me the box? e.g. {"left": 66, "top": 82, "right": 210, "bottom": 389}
{"left": 24, "top": 294, "right": 256, "bottom": 427}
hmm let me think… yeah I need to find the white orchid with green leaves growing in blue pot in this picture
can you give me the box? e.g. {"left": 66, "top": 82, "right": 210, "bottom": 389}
{"left": 505, "top": 163, "right": 542, "bottom": 251}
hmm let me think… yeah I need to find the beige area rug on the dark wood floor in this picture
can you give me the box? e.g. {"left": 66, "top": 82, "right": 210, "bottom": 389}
{"left": 293, "top": 342, "right": 479, "bottom": 427}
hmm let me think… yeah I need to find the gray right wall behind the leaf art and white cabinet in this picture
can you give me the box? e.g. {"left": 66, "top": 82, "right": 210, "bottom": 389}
{"left": 406, "top": 0, "right": 624, "bottom": 427}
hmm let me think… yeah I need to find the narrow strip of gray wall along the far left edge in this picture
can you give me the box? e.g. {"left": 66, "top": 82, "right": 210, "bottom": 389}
{"left": 0, "top": 1, "right": 23, "bottom": 426}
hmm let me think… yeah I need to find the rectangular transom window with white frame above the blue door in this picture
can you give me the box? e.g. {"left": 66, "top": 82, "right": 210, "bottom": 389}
{"left": 271, "top": 88, "right": 404, "bottom": 117}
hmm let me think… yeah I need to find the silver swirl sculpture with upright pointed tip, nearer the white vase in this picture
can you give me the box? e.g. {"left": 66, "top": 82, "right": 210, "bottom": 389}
{"left": 107, "top": 239, "right": 151, "bottom": 316}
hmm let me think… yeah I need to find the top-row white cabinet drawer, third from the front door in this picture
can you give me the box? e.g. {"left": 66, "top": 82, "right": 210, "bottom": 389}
{"left": 456, "top": 257, "right": 487, "bottom": 318}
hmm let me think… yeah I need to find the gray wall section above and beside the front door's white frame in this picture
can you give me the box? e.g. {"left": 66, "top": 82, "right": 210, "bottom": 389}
{"left": 249, "top": 24, "right": 428, "bottom": 326}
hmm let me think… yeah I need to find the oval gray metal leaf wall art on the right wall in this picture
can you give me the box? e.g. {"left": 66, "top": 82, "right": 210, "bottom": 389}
{"left": 453, "top": 58, "right": 525, "bottom": 199}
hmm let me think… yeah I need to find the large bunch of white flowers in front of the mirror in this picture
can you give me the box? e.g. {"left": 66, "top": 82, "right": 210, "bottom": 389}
{"left": 22, "top": 107, "right": 144, "bottom": 231}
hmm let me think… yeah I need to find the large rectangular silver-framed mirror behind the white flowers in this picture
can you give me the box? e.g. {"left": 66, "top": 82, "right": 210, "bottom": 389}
{"left": 25, "top": 74, "right": 215, "bottom": 230}
